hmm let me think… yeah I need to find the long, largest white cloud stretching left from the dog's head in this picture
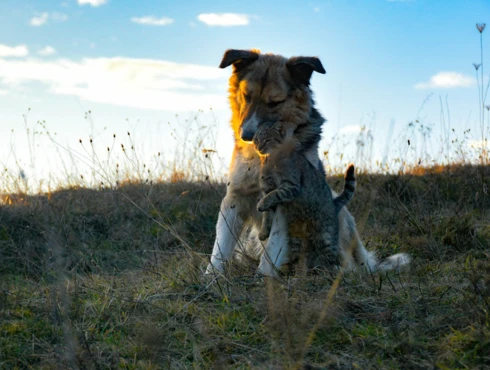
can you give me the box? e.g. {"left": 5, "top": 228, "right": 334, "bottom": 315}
{"left": 0, "top": 58, "right": 228, "bottom": 111}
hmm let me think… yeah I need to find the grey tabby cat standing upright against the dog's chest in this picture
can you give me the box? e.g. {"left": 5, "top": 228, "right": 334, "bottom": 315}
{"left": 253, "top": 122, "right": 356, "bottom": 270}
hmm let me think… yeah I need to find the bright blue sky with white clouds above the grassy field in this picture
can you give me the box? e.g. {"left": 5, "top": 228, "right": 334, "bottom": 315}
{"left": 0, "top": 0, "right": 490, "bottom": 189}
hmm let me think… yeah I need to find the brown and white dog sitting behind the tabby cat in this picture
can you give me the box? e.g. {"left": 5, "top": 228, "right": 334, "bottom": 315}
{"left": 206, "top": 49, "right": 409, "bottom": 276}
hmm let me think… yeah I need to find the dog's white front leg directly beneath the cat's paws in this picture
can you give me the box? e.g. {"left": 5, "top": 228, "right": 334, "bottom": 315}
{"left": 259, "top": 206, "right": 288, "bottom": 276}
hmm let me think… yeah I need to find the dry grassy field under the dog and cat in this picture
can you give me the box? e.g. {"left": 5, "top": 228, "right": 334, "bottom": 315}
{"left": 0, "top": 164, "right": 490, "bottom": 369}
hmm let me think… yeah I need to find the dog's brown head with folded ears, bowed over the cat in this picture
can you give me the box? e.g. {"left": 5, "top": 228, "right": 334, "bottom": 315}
{"left": 220, "top": 50, "right": 325, "bottom": 142}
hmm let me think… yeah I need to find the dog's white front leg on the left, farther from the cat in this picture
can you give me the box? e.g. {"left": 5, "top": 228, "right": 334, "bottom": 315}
{"left": 206, "top": 197, "right": 243, "bottom": 274}
